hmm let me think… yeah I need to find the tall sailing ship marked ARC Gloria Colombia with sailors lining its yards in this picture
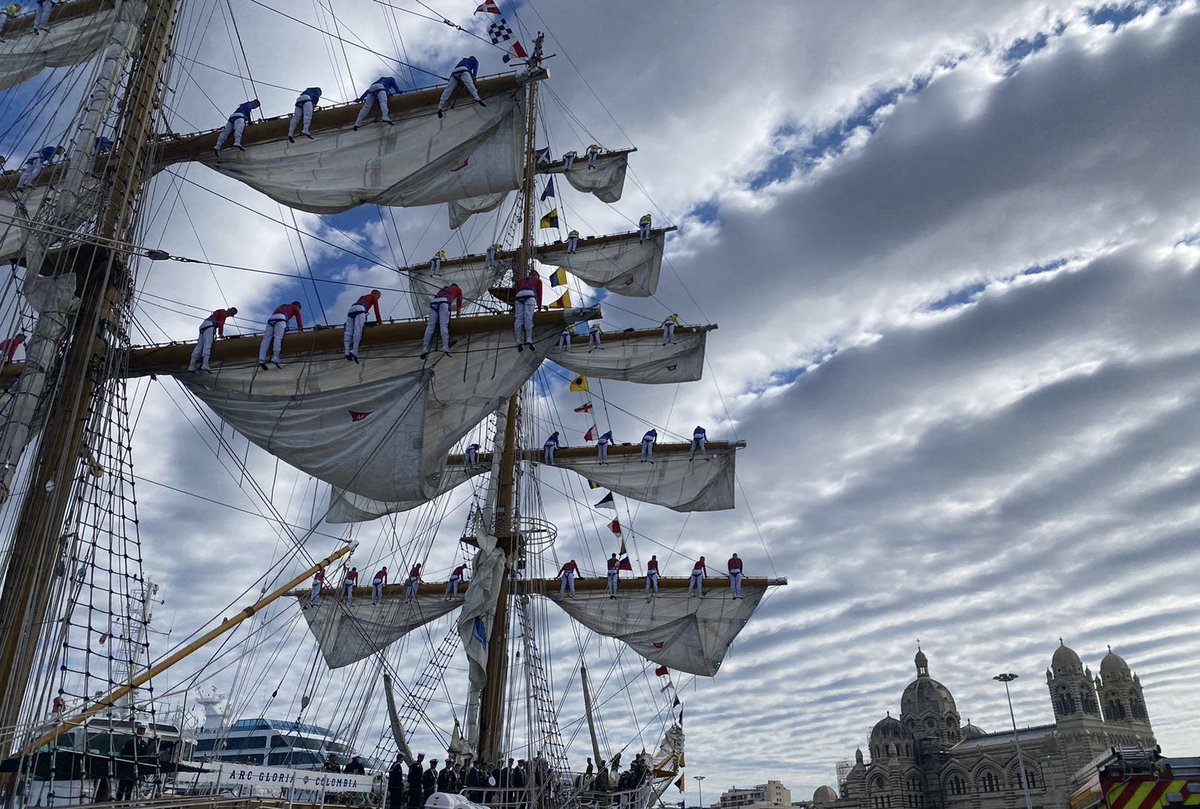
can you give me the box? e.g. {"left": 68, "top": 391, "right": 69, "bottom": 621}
{"left": 0, "top": 0, "right": 786, "bottom": 809}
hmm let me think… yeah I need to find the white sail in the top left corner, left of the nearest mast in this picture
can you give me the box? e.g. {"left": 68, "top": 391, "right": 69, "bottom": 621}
{"left": 0, "top": 8, "right": 116, "bottom": 90}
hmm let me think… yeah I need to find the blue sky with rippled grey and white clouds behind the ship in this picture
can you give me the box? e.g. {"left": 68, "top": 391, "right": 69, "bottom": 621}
{"left": 2, "top": 0, "right": 1200, "bottom": 801}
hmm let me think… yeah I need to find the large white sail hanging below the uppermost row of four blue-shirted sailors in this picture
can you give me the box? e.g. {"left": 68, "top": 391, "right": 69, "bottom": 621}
{"left": 169, "top": 90, "right": 526, "bottom": 214}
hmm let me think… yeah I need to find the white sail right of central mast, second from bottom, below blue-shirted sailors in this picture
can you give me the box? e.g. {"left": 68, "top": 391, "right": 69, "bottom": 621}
{"left": 554, "top": 444, "right": 740, "bottom": 511}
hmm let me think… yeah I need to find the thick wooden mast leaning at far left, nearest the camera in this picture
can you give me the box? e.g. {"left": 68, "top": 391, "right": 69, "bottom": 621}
{"left": 0, "top": 0, "right": 178, "bottom": 756}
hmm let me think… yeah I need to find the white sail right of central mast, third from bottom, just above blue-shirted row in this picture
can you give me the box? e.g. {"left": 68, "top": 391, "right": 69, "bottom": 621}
{"left": 550, "top": 326, "right": 709, "bottom": 384}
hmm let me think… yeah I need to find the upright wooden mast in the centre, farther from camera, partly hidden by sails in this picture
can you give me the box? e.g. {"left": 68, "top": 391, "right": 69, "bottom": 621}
{"left": 478, "top": 31, "right": 544, "bottom": 762}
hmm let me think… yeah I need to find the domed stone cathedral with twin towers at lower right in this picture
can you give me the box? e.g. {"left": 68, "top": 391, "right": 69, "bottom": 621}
{"left": 818, "top": 643, "right": 1154, "bottom": 809}
